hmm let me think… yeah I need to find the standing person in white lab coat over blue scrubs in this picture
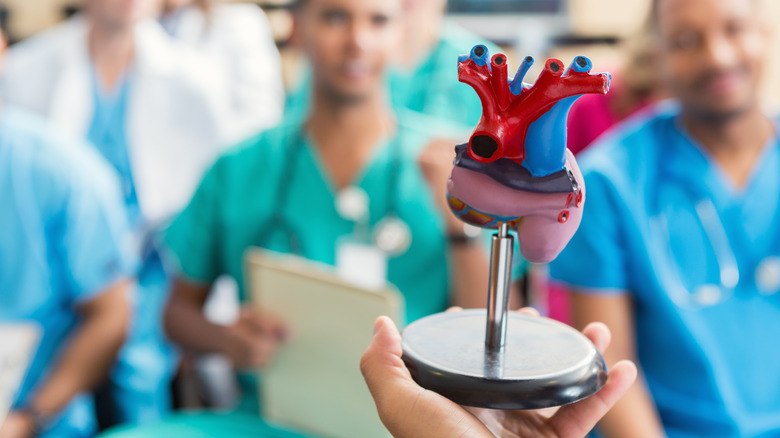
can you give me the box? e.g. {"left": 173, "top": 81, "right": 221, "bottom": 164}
{"left": 0, "top": 0, "right": 230, "bottom": 424}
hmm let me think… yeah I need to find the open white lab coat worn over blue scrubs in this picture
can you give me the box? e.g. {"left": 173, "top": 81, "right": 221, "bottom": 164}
{"left": 0, "top": 16, "right": 229, "bottom": 225}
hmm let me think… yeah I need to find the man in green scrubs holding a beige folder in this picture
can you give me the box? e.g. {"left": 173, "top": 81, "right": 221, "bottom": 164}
{"left": 156, "top": 0, "right": 487, "bottom": 428}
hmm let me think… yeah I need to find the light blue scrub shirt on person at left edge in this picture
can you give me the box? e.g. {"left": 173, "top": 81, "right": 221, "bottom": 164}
{"left": 0, "top": 107, "right": 136, "bottom": 438}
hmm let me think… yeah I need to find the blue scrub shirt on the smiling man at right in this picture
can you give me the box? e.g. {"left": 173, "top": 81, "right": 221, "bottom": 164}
{"left": 550, "top": 102, "right": 780, "bottom": 438}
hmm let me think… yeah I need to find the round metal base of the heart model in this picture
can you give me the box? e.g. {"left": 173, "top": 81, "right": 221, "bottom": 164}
{"left": 403, "top": 309, "right": 607, "bottom": 409}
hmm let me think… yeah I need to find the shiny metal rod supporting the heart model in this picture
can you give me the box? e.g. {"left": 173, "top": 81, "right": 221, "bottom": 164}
{"left": 485, "top": 223, "right": 514, "bottom": 351}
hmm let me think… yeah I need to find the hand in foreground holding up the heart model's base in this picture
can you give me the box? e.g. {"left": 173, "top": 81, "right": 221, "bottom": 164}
{"left": 360, "top": 310, "right": 637, "bottom": 438}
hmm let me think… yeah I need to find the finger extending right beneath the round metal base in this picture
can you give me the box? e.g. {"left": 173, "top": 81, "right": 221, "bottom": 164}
{"left": 550, "top": 360, "right": 637, "bottom": 438}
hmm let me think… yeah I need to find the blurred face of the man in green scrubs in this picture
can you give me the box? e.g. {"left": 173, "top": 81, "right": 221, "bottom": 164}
{"left": 296, "top": 0, "right": 401, "bottom": 102}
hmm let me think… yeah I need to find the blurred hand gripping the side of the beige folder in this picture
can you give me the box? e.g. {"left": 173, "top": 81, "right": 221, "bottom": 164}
{"left": 223, "top": 308, "right": 290, "bottom": 369}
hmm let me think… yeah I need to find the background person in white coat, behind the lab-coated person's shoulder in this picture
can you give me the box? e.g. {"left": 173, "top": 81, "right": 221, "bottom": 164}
{"left": 160, "top": 0, "right": 284, "bottom": 142}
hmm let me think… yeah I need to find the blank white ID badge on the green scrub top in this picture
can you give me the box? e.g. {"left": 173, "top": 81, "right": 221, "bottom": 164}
{"left": 336, "top": 238, "right": 387, "bottom": 289}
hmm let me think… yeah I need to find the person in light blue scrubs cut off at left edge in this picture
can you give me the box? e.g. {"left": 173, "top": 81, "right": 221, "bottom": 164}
{"left": 0, "top": 28, "right": 136, "bottom": 438}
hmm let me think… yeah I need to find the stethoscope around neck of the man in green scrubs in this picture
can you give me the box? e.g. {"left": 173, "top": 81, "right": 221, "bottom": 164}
{"left": 255, "top": 126, "right": 412, "bottom": 256}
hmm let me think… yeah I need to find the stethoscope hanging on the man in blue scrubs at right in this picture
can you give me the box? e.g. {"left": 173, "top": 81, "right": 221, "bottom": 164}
{"left": 650, "top": 128, "right": 780, "bottom": 310}
